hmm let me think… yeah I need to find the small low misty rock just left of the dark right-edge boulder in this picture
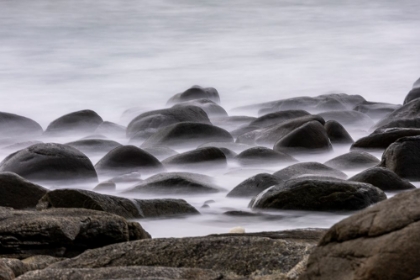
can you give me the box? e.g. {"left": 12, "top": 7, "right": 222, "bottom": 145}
{"left": 324, "top": 151, "right": 380, "bottom": 170}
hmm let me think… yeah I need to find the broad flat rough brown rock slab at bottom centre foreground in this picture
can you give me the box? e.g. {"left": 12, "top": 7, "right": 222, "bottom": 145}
{"left": 45, "top": 230, "right": 320, "bottom": 275}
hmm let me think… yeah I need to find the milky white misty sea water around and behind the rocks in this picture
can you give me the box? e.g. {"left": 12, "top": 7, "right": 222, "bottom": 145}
{"left": 0, "top": 0, "right": 420, "bottom": 237}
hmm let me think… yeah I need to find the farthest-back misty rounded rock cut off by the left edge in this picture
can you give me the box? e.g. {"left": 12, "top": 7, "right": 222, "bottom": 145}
{"left": 0, "top": 112, "right": 43, "bottom": 138}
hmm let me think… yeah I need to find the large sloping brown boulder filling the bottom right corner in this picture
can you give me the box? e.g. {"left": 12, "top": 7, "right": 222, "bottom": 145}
{"left": 300, "top": 190, "right": 420, "bottom": 280}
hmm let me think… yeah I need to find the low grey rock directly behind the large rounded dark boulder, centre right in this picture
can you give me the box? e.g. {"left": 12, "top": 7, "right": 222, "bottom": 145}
{"left": 273, "top": 162, "right": 347, "bottom": 181}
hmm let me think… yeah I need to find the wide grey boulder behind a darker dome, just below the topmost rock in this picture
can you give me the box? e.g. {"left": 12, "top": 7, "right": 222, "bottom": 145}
{"left": 127, "top": 105, "right": 211, "bottom": 138}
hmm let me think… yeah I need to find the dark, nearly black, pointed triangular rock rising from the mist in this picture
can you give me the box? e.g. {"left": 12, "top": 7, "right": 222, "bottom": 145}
{"left": 273, "top": 121, "right": 332, "bottom": 153}
